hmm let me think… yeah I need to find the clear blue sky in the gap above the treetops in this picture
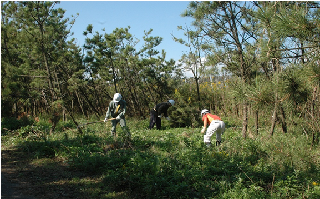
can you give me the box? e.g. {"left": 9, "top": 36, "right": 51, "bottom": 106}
{"left": 55, "top": 1, "right": 192, "bottom": 61}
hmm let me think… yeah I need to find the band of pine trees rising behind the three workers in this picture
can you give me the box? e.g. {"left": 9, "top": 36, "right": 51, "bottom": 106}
{"left": 1, "top": 2, "right": 320, "bottom": 140}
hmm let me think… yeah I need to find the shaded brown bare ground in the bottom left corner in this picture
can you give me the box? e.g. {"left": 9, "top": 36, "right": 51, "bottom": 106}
{"left": 1, "top": 149, "right": 83, "bottom": 199}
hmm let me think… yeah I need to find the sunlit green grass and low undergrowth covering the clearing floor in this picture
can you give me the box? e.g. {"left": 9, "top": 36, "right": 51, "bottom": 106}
{"left": 1, "top": 116, "right": 320, "bottom": 198}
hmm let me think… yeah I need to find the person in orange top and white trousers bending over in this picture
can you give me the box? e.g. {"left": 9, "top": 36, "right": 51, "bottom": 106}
{"left": 201, "top": 109, "right": 225, "bottom": 147}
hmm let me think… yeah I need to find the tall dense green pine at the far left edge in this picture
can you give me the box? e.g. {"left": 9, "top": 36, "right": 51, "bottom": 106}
{"left": 1, "top": 1, "right": 81, "bottom": 132}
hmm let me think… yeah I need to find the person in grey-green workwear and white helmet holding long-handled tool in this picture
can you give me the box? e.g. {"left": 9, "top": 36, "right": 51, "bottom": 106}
{"left": 104, "top": 93, "right": 130, "bottom": 138}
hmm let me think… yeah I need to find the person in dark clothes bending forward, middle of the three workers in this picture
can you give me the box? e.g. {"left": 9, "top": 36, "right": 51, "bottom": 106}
{"left": 149, "top": 100, "right": 175, "bottom": 130}
